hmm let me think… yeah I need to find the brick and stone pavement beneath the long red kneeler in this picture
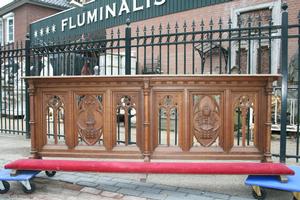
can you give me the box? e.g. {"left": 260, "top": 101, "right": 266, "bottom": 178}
{"left": 0, "top": 134, "right": 292, "bottom": 200}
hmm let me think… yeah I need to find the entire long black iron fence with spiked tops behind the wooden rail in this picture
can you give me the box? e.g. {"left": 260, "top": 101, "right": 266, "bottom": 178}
{"left": 0, "top": 5, "right": 300, "bottom": 162}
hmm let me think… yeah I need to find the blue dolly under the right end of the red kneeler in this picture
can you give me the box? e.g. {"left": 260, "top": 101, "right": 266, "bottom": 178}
{"left": 245, "top": 166, "right": 300, "bottom": 200}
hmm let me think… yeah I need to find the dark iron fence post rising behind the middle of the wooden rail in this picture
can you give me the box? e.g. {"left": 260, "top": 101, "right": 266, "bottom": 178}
{"left": 125, "top": 19, "right": 131, "bottom": 75}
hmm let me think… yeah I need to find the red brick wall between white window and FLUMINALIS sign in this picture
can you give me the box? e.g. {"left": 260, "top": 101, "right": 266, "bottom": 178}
{"left": 13, "top": 4, "right": 59, "bottom": 41}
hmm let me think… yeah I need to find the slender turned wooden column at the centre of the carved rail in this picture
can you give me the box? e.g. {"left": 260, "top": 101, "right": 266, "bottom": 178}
{"left": 144, "top": 79, "right": 151, "bottom": 162}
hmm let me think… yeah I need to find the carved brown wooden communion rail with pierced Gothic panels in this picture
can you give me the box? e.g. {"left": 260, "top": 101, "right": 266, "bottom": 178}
{"left": 26, "top": 75, "right": 279, "bottom": 162}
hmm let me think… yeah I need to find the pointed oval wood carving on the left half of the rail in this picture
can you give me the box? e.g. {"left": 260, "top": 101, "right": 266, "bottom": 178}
{"left": 77, "top": 95, "right": 103, "bottom": 146}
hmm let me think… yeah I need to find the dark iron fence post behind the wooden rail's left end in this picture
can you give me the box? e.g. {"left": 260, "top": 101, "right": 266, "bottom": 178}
{"left": 25, "top": 33, "right": 30, "bottom": 139}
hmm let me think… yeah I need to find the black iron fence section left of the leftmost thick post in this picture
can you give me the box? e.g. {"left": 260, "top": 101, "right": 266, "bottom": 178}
{"left": 0, "top": 43, "right": 28, "bottom": 134}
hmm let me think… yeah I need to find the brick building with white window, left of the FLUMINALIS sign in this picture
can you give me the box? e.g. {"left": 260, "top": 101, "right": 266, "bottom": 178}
{"left": 0, "top": 0, "right": 70, "bottom": 44}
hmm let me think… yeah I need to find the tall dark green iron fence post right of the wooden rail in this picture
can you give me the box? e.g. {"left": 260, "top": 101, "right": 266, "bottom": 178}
{"left": 280, "top": 3, "right": 288, "bottom": 163}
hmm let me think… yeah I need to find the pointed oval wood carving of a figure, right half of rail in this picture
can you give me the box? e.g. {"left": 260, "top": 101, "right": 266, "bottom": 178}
{"left": 193, "top": 96, "right": 221, "bottom": 147}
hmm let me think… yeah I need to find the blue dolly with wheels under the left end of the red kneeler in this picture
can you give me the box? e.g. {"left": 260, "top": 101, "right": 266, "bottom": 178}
{"left": 0, "top": 169, "right": 40, "bottom": 194}
